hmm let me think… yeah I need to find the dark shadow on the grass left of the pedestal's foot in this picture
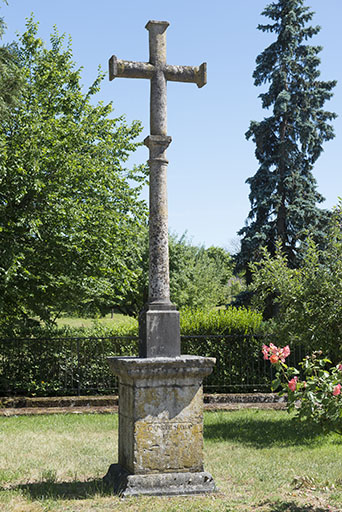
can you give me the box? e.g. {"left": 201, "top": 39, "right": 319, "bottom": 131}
{"left": 7, "top": 479, "right": 113, "bottom": 500}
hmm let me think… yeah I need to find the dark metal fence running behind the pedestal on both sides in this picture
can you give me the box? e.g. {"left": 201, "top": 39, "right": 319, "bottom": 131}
{"left": 0, "top": 335, "right": 302, "bottom": 396}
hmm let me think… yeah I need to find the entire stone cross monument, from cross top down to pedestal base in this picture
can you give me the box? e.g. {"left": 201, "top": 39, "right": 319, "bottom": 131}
{"left": 108, "top": 20, "right": 215, "bottom": 495}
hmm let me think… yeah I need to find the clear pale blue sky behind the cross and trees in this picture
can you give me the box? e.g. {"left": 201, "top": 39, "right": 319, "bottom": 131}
{"left": 0, "top": 0, "right": 342, "bottom": 250}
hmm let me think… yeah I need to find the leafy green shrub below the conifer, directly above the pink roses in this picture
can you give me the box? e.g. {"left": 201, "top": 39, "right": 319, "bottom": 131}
{"left": 251, "top": 205, "right": 342, "bottom": 362}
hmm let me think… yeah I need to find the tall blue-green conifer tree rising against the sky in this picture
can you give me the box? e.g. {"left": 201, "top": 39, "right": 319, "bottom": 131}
{"left": 237, "top": 0, "right": 336, "bottom": 278}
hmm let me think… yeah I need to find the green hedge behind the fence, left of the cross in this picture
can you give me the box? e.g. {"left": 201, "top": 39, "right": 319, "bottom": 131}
{"left": 0, "top": 319, "right": 138, "bottom": 396}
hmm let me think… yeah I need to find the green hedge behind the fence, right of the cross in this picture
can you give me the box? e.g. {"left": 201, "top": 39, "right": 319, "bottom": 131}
{"left": 180, "top": 307, "right": 270, "bottom": 393}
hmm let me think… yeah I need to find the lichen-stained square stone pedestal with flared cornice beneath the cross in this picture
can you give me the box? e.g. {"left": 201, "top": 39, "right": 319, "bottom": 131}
{"left": 105, "top": 356, "right": 215, "bottom": 496}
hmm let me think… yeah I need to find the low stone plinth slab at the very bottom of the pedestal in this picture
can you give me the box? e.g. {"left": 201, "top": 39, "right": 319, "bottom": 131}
{"left": 104, "top": 464, "right": 216, "bottom": 497}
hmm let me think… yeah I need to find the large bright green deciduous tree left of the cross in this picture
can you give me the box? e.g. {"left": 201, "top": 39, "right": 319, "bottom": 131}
{"left": 0, "top": 19, "right": 146, "bottom": 332}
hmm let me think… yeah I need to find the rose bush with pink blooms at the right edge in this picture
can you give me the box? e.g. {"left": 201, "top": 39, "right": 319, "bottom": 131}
{"left": 262, "top": 343, "right": 342, "bottom": 435}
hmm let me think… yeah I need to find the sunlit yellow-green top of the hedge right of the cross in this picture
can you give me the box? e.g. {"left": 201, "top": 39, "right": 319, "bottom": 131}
{"left": 180, "top": 307, "right": 262, "bottom": 335}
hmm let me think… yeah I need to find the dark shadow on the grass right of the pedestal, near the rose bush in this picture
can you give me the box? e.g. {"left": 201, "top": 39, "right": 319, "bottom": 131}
{"left": 204, "top": 412, "right": 342, "bottom": 448}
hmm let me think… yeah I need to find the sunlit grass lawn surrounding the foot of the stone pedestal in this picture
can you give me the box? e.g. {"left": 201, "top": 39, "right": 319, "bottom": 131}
{"left": 0, "top": 410, "right": 342, "bottom": 512}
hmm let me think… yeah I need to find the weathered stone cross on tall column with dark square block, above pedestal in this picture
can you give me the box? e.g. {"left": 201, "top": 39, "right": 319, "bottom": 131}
{"left": 109, "top": 21, "right": 207, "bottom": 357}
